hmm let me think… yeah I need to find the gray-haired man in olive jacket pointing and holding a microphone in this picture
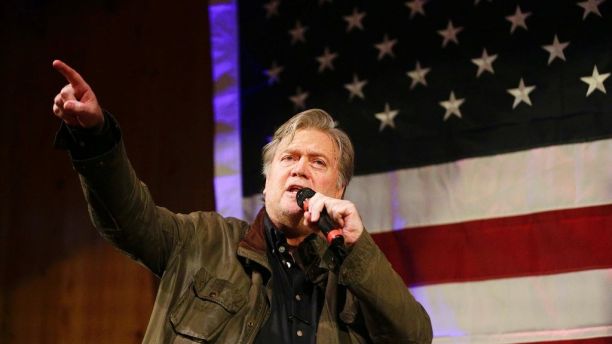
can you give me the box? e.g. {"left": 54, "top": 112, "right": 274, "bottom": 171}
{"left": 53, "top": 61, "right": 432, "bottom": 343}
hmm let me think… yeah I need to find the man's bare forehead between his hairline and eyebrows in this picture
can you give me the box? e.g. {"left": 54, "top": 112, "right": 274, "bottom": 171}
{"left": 277, "top": 129, "right": 337, "bottom": 159}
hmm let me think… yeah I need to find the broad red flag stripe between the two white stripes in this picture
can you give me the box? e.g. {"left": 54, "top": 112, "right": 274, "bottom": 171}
{"left": 374, "top": 205, "right": 612, "bottom": 286}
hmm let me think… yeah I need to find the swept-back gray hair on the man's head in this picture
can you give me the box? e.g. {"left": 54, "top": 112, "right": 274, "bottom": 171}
{"left": 261, "top": 109, "right": 355, "bottom": 188}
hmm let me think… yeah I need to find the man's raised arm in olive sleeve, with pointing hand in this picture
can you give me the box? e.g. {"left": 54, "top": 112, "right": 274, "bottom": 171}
{"left": 53, "top": 60, "right": 193, "bottom": 275}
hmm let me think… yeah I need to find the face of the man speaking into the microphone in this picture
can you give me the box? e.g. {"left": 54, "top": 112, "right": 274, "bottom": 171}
{"left": 264, "top": 129, "right": 344, "bottom": 229}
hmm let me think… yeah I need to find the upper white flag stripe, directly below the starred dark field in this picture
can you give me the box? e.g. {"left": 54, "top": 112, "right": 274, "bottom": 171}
{"left": 243, "top": 139, "right": 612, "bottom": 227}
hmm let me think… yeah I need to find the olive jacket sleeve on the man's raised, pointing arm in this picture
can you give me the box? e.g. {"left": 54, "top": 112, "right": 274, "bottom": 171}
{"left": 73, "top": 132, "right": 196, "bottom": 276}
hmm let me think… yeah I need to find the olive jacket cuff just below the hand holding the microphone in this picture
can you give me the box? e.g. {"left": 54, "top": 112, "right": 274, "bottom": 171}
{"left": 338, "top": 229, "right": 381, "bottom": 286}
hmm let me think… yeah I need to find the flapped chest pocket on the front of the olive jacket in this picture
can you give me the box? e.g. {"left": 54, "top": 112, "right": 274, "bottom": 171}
{"left": 170, "top": 268, "right": 246, "bottom": 341}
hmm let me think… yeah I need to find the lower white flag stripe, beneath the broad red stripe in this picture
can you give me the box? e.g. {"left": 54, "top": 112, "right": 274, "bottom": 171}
{"left": 411, "top": 269, "right": 612, "bottom": 343}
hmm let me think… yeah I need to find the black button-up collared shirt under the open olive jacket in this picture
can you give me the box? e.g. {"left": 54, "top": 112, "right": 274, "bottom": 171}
{"left": 255, "top": 216, "right": 324, "bottom": 344}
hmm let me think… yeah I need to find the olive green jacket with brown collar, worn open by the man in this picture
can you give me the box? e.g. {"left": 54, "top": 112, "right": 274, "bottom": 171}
{"left": 73, "top": 142, "right": 432, "bottom": 344}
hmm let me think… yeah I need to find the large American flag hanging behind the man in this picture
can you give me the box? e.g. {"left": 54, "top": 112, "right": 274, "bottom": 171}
{"left": 208, "top": 0, "right": 612, "bottom": 343}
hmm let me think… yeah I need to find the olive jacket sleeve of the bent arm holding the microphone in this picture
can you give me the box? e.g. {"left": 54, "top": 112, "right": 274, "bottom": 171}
{"left": 339, "top": 231, "right": 433, "bottom": 343}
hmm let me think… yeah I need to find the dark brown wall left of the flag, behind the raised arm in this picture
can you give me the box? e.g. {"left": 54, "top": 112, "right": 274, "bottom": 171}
{"left": 0, "top": 0, "right": 214, "bottom": 343}
